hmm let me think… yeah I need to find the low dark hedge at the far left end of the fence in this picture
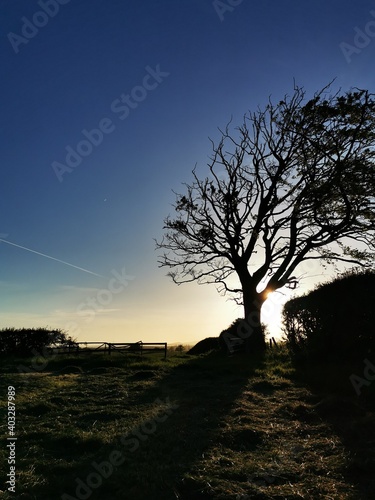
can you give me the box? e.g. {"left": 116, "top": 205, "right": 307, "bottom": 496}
{"left": 0, "top": 328, "right": 74, "bottom": 356}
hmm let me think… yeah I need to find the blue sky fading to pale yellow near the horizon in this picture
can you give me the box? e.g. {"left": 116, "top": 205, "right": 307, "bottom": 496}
{"left": 0, "top": 0, "right": 375, "bottom": 343}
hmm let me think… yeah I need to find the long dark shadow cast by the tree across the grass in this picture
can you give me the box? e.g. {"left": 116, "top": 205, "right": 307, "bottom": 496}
{"left": 60, "top": 352, "right": 262, "bottom": 500}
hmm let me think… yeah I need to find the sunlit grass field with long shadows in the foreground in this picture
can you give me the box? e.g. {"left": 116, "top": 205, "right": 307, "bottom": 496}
{"left": 0, "top": 348, "right": 375, "bottom": 500}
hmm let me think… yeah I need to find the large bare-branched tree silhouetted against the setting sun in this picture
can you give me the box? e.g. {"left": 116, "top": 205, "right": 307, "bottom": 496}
{"left": 157, "top": 85, "right": 375, "bottom": 347}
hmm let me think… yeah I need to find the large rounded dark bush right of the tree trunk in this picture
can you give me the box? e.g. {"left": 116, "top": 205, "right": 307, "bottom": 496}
{"left": 283, "top": 270, "right": 375, "bottom": 362}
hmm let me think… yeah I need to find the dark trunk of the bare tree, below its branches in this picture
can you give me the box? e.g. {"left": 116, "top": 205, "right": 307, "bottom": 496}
{"left": 241, "top": 288, "right": 266, "bottom": 354}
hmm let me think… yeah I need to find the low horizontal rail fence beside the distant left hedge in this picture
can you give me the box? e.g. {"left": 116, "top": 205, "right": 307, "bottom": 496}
{"left": 52, "top": 340, "right": 168, "bottom": 359}
